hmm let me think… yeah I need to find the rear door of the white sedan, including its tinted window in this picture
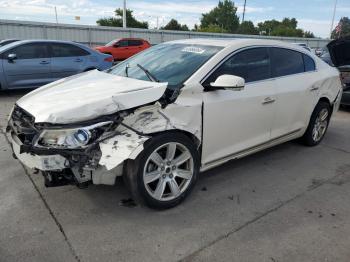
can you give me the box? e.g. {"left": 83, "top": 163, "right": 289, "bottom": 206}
{"left": 270, "top": 47, "right": 319, "bottom": 139}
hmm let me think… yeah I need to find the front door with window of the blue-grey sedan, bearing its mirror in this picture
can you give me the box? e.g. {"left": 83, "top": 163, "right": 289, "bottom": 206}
{"left": 2, "top": 43, "right": 53, "bottom": 88}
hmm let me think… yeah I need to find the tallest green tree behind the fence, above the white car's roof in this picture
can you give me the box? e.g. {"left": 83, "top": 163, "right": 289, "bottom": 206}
{"left": 200, "top": 0, "right": 239, "bottom": 33}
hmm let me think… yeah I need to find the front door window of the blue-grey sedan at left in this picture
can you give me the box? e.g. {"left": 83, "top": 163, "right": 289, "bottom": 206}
{"left": 5, "top": 43, "right": 49, "bottom": 59}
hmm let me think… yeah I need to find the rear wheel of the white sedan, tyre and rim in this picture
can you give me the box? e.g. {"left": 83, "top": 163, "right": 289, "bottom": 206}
{"left": 301, "top": 101, "right": 331, "bottom": 146}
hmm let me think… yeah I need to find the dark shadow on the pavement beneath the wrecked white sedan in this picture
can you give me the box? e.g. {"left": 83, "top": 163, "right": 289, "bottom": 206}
{"left": 77, "top": 140, "right": 305, "bottom": 213}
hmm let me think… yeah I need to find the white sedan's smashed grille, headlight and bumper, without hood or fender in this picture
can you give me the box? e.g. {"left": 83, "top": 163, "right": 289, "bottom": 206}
{"left": 6, "top": 105, "right": 149, "bottom": 187}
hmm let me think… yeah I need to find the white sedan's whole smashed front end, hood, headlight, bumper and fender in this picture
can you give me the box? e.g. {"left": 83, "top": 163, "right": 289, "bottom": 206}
{"left": 7, "top": 65, "right": 202, "bottom": 186}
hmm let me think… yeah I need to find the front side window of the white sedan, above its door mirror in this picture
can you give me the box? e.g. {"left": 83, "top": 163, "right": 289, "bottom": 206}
{"left": 204, "top": 47, "right": 271, "bottom": 85}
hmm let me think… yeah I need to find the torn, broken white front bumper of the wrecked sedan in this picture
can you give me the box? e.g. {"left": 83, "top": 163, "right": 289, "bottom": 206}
{"left": 7, "top": 124, "right": 148, "bottom": 185}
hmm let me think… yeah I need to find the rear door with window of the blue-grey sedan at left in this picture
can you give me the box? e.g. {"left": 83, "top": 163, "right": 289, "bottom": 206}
{"left": 50, "top": 43, "right": 90, "bottom": 79}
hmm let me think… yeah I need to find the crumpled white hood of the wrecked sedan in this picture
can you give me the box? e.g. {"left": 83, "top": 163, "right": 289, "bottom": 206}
{"left": 16, "top": 70, "right": 167, "bottom": 124}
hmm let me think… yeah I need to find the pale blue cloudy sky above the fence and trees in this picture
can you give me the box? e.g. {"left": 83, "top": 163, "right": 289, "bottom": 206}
{"left": 0, "top": 0, "right": 350, "bottom": 38}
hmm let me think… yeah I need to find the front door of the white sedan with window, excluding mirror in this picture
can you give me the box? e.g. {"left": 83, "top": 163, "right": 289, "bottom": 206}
{"left": 202, "top": 47, "right": 275, "bottom": 165}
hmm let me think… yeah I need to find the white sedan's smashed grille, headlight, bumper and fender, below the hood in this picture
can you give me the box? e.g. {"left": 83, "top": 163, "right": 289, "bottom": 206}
{"left": 7, "top": 91, "right": 202, "bottom": 187}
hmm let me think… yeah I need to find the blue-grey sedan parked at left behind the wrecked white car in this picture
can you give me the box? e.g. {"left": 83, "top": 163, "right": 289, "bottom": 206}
{"left": 0, "top": 40, "right": 113, "bottom": 90}
